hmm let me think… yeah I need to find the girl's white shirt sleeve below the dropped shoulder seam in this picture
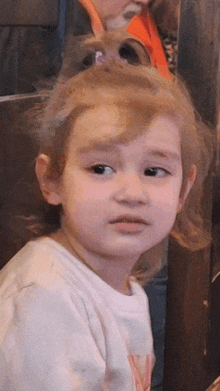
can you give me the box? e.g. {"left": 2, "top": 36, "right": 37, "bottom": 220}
{"left": 0, "top": 285, "right": 105, "bottom": 391}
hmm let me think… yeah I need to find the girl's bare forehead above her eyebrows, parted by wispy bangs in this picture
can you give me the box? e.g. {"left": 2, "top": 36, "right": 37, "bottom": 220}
{"left": 70, "top": 105, "right": 180, "bottom": 157}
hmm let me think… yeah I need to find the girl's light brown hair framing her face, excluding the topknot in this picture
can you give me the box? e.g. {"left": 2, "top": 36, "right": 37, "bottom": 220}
{"left": 20, "top": 61, "right": 212, "bottom": 282}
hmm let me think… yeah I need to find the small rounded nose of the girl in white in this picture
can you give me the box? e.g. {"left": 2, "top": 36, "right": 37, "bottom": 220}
{"left": 115, "top": 174, "right": 148, "bottom": 205}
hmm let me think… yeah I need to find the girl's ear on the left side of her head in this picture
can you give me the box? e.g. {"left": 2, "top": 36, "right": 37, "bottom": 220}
{"left": 35, "top": 153, "right": 61, "bottom": 205}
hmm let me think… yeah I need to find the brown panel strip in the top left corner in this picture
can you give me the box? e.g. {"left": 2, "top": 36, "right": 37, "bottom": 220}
{"left": 0, "top": 0, "right": 59, "bottom": 26}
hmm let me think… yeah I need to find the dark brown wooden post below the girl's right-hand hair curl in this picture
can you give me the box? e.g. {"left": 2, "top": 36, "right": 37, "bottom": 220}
{"left": 164, "top": 242, "right": 209, "bottom": 391}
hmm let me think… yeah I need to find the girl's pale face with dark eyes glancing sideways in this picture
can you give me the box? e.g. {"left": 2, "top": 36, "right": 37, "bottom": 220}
{"left": 38, "top": 107, "right": 189, "bottom": 259}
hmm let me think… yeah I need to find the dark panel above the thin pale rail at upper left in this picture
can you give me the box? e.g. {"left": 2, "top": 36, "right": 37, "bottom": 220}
{"left": 0, "top": 26, "right": 61, "bottom": 96}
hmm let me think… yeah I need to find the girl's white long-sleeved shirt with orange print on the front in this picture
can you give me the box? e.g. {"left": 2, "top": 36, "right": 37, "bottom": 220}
{"left": 0, "top": 237, "right": 154, "bottom": 391}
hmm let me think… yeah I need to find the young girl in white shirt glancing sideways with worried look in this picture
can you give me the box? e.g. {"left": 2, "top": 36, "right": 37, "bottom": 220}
{"left": 0, "top": 63, "right": 212, "bottom": 391}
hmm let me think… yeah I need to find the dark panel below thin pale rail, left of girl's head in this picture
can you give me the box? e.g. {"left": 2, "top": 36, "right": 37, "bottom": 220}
{"left": 0, "top": 94, "right": 47, "bottom": 268}
